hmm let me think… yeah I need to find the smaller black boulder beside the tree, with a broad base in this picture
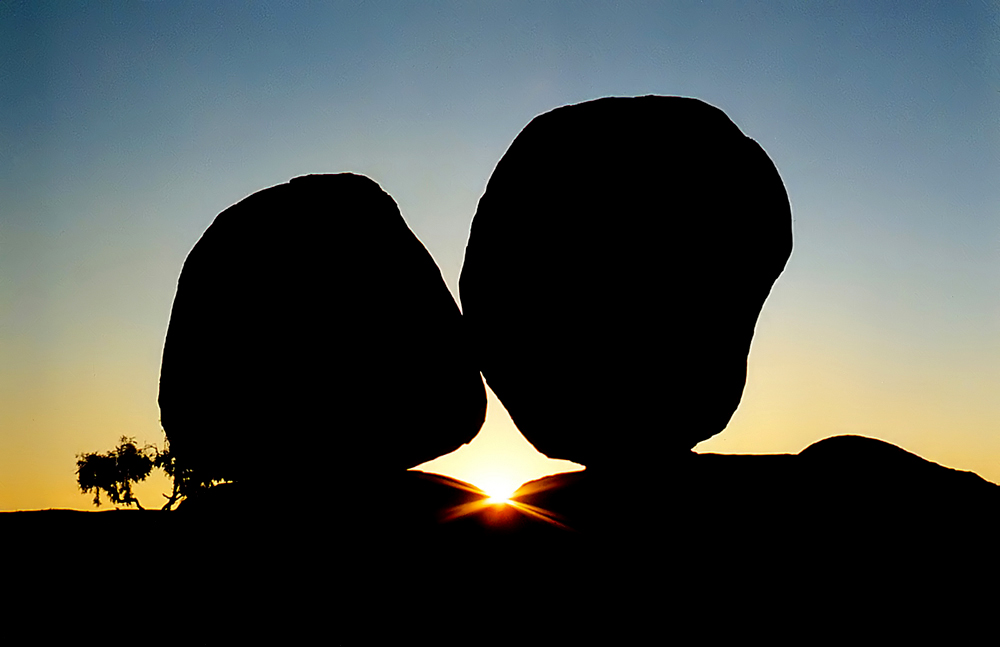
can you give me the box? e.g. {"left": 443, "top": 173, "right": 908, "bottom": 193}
{"left": 159, "top": 173, "right": 486, "bottom": 499}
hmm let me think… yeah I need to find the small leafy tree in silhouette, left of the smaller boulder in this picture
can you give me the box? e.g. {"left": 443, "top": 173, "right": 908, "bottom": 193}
{"left": 76, "top": 436, "right": 159, "bottom": 510}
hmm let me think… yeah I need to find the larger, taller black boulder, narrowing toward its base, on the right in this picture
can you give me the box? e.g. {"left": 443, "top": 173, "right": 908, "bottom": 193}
{"left": 460, "top": 96, "right": 792, "bottom": 466}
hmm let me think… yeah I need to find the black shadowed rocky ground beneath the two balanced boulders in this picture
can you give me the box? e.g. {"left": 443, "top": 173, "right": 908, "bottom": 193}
{"left": 7, "top": 436, "right": 1000, "bottom": 644}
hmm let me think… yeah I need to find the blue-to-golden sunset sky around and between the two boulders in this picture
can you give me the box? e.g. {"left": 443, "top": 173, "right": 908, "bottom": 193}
{"left": 0, "top": 0, "right": 1000, "bottom": 510}
